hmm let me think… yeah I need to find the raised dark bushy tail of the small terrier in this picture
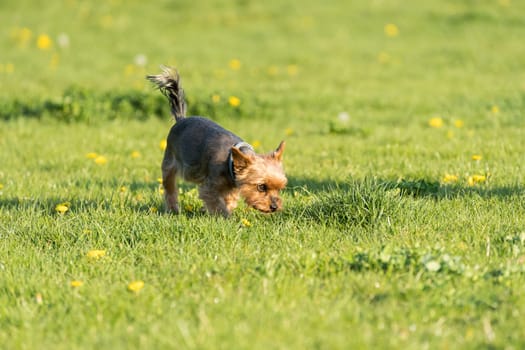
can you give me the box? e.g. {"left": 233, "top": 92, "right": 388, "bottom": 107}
{"left": 146, "top": 66, "right": 186, "bottom": 122}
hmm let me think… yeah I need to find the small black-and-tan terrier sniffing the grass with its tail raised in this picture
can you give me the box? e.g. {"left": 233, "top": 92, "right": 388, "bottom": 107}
{"left": 147, "top": 67, "right": 287, "bottom": 217}
